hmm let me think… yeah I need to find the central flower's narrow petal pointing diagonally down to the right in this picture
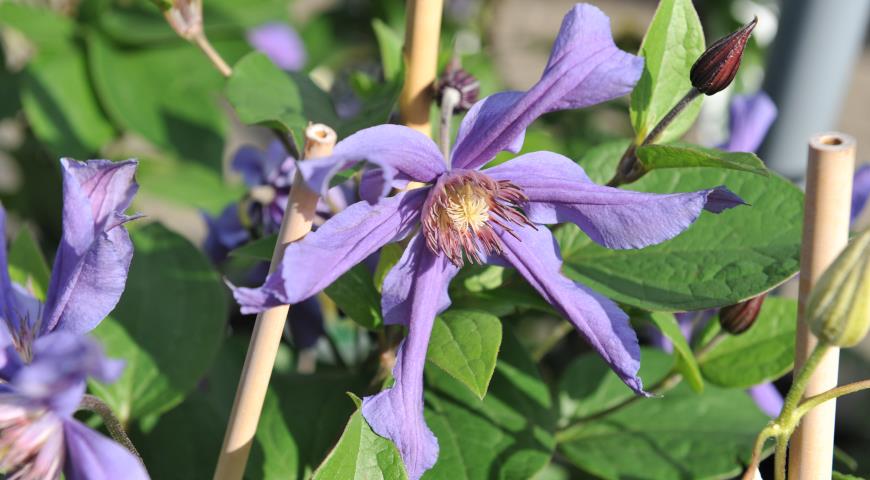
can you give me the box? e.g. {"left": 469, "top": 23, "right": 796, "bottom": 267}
{"left": 500, "top": 226, "right": 646, "bottom": 395}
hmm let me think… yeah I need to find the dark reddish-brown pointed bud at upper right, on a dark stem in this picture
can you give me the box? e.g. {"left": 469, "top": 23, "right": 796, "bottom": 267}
{"left": 689, "top": 17, "right": 758, "bottom": 95}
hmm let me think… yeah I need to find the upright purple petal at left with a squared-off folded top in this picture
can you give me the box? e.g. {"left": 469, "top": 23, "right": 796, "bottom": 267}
{"left": 40, "top": 158, "right": 138, "bottom": 333}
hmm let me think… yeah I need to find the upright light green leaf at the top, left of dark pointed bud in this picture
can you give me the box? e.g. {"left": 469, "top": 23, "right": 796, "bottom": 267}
{"left": 631, "top": 0, "right": 704, "bottom": 144}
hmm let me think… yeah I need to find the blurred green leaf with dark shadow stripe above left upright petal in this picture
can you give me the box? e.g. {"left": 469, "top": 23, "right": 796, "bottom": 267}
{"left": 21, "top": 43, "right": 115, "bottom": 158}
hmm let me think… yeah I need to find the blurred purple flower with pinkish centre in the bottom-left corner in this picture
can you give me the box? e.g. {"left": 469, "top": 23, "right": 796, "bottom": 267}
{"left": 0, "top": 331, "right": 148, "bottom": 480}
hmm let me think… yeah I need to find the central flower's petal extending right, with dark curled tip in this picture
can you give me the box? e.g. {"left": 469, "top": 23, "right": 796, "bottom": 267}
{"left": 486, "top": 152, "right": 743, "bottom": 249}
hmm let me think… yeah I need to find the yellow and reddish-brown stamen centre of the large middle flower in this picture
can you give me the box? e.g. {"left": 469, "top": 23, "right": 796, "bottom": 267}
{"left": 422, "top": 171, "right": 534, "bottom": 267}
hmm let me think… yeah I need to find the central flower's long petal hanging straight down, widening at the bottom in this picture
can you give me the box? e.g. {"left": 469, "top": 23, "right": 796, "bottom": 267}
{"left": 362, "top": 240, "right": 456, "bottom": 480}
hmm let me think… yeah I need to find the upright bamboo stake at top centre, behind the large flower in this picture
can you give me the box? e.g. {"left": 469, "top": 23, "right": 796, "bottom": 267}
{"left": 399, "top": 0, "right": 444, "bottom": 136}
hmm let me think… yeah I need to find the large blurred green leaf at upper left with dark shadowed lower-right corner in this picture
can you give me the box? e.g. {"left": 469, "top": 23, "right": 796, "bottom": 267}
{"left": 87, "top": 31, "right": 235, "bottom": 171}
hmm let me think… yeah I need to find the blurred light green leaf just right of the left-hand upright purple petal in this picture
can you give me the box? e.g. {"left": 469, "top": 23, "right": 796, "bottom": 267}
{"left": 136, "top": 158, "right": 249, "bottom": 214}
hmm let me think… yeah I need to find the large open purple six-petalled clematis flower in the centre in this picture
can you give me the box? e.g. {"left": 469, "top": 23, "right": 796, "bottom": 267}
{"left": 234, "top": 4, "right": 742, "bottom": 479}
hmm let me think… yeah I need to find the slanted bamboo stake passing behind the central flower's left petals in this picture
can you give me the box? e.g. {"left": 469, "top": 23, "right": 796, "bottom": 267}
{"left": 214, "top": 124, "right": 337, "bottom": 480}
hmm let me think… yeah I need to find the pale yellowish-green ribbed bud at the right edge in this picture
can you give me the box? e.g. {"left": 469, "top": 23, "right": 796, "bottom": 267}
{"left": 805, "top": 229, "right": 870, "bottom": 347}
